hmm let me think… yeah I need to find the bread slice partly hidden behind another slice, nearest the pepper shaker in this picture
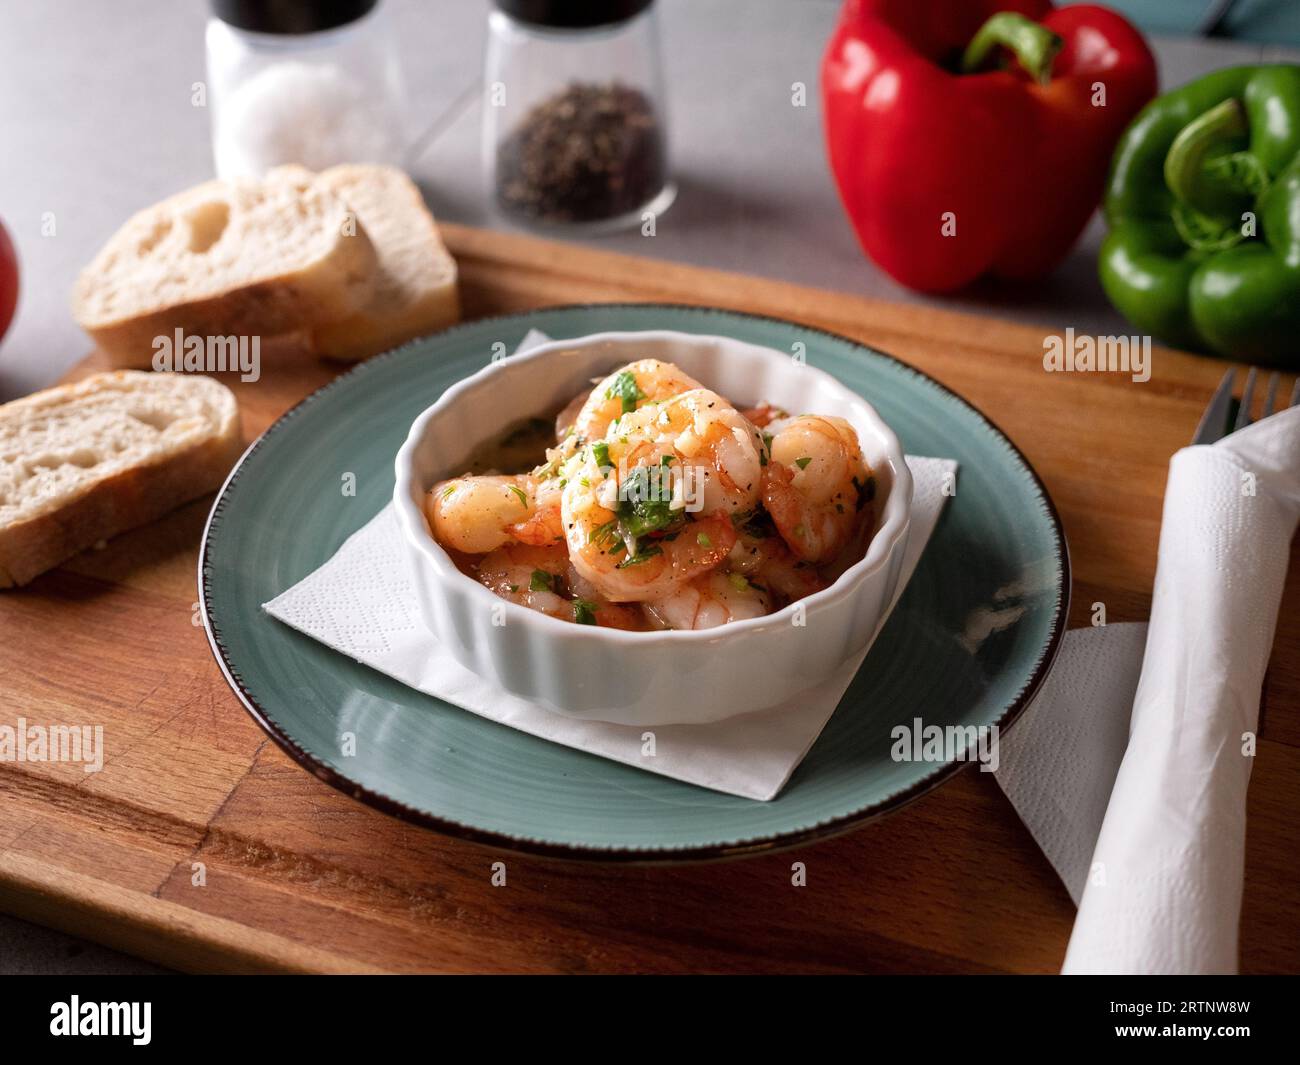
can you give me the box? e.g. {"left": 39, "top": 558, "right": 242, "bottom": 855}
{"left": 305, "top": 164, "right": 460, "bottom": 359}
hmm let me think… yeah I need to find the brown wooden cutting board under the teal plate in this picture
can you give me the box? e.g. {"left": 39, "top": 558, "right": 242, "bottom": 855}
{"left": 0, "top": 226, "right": 1300, "bottom": 973}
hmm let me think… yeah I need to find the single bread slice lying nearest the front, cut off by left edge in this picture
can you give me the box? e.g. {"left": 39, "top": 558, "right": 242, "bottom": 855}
{"left": 0, "top": 371, "right": 242, "bottom": 588}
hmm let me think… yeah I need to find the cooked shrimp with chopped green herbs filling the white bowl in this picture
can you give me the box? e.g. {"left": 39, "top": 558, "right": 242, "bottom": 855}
{"left": 424, "top": 359, "right": 876, "bottom": 632}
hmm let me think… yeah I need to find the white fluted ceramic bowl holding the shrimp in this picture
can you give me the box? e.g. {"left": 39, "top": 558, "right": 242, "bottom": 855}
{"left": 394, "top": 332, "right": 911, "bottom": 726}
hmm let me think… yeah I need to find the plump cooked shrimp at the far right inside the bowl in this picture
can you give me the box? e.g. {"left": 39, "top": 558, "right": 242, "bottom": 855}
{"left": 763, "top": 415, "right": 875, "bottom": 562}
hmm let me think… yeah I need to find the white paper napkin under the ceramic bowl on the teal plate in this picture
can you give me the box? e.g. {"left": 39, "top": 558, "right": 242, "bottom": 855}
{"left": 263, "top": 330, "right": 957, "bottom": 800}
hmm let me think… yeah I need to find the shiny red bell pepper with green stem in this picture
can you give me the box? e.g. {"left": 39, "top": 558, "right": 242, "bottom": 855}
{"left": 822, "top": 0, "right": 1156, "bottom": 291}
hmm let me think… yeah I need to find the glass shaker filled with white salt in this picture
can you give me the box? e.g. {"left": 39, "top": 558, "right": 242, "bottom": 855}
{"left": 207, "top": 0, "right": 407, "bottom": 178}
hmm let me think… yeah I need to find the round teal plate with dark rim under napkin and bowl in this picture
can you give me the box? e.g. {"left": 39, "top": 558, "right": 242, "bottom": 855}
{"left": 199, "top": 303, "right": 1070, "bottom": 861}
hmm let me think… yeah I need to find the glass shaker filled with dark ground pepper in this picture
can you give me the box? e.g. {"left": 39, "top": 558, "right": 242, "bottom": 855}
{"left": 482, "top": 0, "right": 675, "bottom": 229}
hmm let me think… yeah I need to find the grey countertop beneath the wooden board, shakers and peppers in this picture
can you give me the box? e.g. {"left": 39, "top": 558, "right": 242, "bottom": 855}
{"left": 0, "top": 0, "right": 1294, "bottom": 973}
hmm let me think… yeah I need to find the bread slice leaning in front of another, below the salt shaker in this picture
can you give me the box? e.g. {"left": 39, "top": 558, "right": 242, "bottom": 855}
{"left": 73, "top": 179, "right": 377, "bottom": 367}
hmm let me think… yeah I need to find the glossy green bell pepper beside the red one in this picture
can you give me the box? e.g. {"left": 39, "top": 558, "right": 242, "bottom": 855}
{"left": 1099, "top": 64, "right": 1300, "bottom": 368}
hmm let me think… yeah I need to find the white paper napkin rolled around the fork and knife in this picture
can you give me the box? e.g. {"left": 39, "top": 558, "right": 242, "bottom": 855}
{"left": 998, "top": 408, "right": 1300, "bottom": 973}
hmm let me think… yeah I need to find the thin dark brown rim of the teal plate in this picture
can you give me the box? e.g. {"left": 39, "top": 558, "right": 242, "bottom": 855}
{"left": 198, "top": 300, "right": 1073, "bottom": 865}
